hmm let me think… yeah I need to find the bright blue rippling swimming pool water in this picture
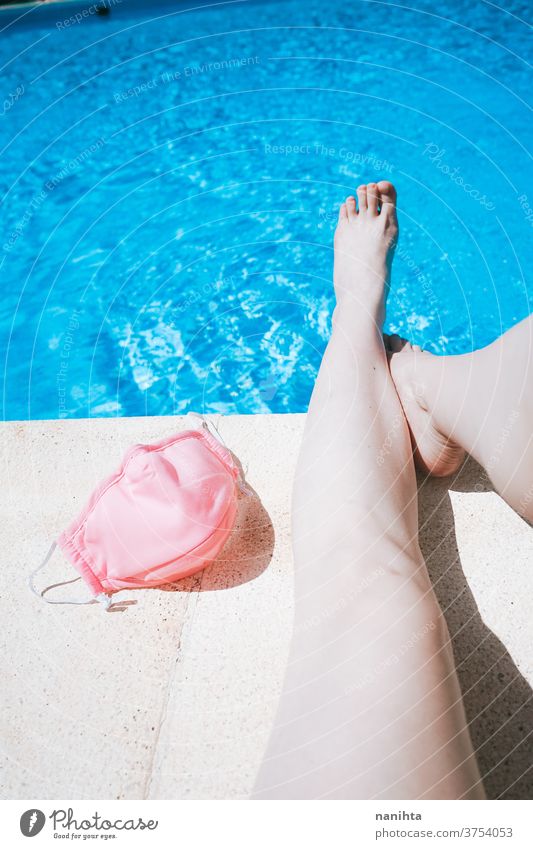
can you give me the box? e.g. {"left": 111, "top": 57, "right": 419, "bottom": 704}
{"left": 0, "top": 0, "right": 533, "bottom": 419}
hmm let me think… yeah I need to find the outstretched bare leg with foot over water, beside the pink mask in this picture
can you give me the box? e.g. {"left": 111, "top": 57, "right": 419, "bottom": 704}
{"left": 254, "top": 182, "right": 483, "bottom": 799}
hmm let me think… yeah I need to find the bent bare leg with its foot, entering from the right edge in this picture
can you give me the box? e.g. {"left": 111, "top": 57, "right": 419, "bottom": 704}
{"left": 391, "top": 316, "right": 533, "bottom": 521}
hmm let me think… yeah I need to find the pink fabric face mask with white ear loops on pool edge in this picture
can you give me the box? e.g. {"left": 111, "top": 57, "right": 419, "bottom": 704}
{"left": 30, "top": 421, "right": 240, "bottom": 607}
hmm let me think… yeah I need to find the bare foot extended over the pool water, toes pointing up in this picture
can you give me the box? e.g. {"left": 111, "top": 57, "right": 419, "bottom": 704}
{"left": 333, "top": 180, "right": 398, "bottom": 329}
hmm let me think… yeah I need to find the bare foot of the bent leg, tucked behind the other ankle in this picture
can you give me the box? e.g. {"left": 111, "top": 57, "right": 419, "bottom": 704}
{"left": 384, "top": 336, "right": 465, "bottom": 477}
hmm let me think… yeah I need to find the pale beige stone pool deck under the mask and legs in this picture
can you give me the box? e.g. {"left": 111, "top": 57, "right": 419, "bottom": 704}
{"left": 1, "top": 415, "right": 533, "bottom": 799}
